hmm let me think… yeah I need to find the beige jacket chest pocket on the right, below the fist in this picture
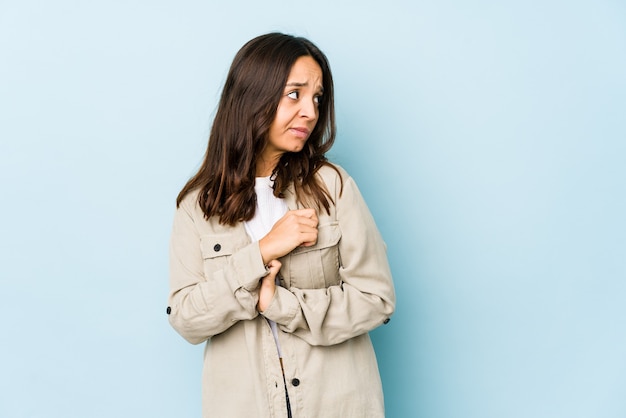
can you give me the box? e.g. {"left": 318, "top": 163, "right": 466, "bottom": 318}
{"left": 281, "top": 222, "right": 341, "bottom": 289}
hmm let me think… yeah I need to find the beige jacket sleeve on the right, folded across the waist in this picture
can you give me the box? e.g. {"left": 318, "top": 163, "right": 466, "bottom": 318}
{"left": 263, "top": 175, "right": 395, "bottom": 345}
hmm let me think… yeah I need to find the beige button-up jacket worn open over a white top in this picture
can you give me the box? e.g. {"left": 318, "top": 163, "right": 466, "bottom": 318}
{"left": 168, "top": 167, "right": 395, "bottom": 418}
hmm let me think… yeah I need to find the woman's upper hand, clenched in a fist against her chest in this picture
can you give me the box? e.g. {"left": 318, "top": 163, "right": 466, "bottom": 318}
{"left": 259, "top": 209, "right": 318, "bottom": 264}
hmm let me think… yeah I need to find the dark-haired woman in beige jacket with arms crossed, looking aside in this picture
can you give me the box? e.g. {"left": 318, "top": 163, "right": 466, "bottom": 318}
{"left": 167, "top": 33, "right": 395, "bottom": 418}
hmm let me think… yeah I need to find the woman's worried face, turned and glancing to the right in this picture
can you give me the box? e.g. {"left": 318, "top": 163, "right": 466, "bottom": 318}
{"left": 261, "top": 56, "right": 323, "bottom": 168}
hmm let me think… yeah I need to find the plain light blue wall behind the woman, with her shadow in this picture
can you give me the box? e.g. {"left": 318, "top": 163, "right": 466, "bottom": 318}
{"left": 0, "top": 0, "right": 626, "bottom": 418}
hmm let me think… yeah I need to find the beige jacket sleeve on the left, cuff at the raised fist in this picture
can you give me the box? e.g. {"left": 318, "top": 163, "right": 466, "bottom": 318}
{"left": 168, "top": 199, "right": 268, "bottom": 344}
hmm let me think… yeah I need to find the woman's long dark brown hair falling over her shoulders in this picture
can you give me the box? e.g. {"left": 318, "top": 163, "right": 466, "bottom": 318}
{"left": 176, "top": 33, "right": 336, "bottom": 225}
